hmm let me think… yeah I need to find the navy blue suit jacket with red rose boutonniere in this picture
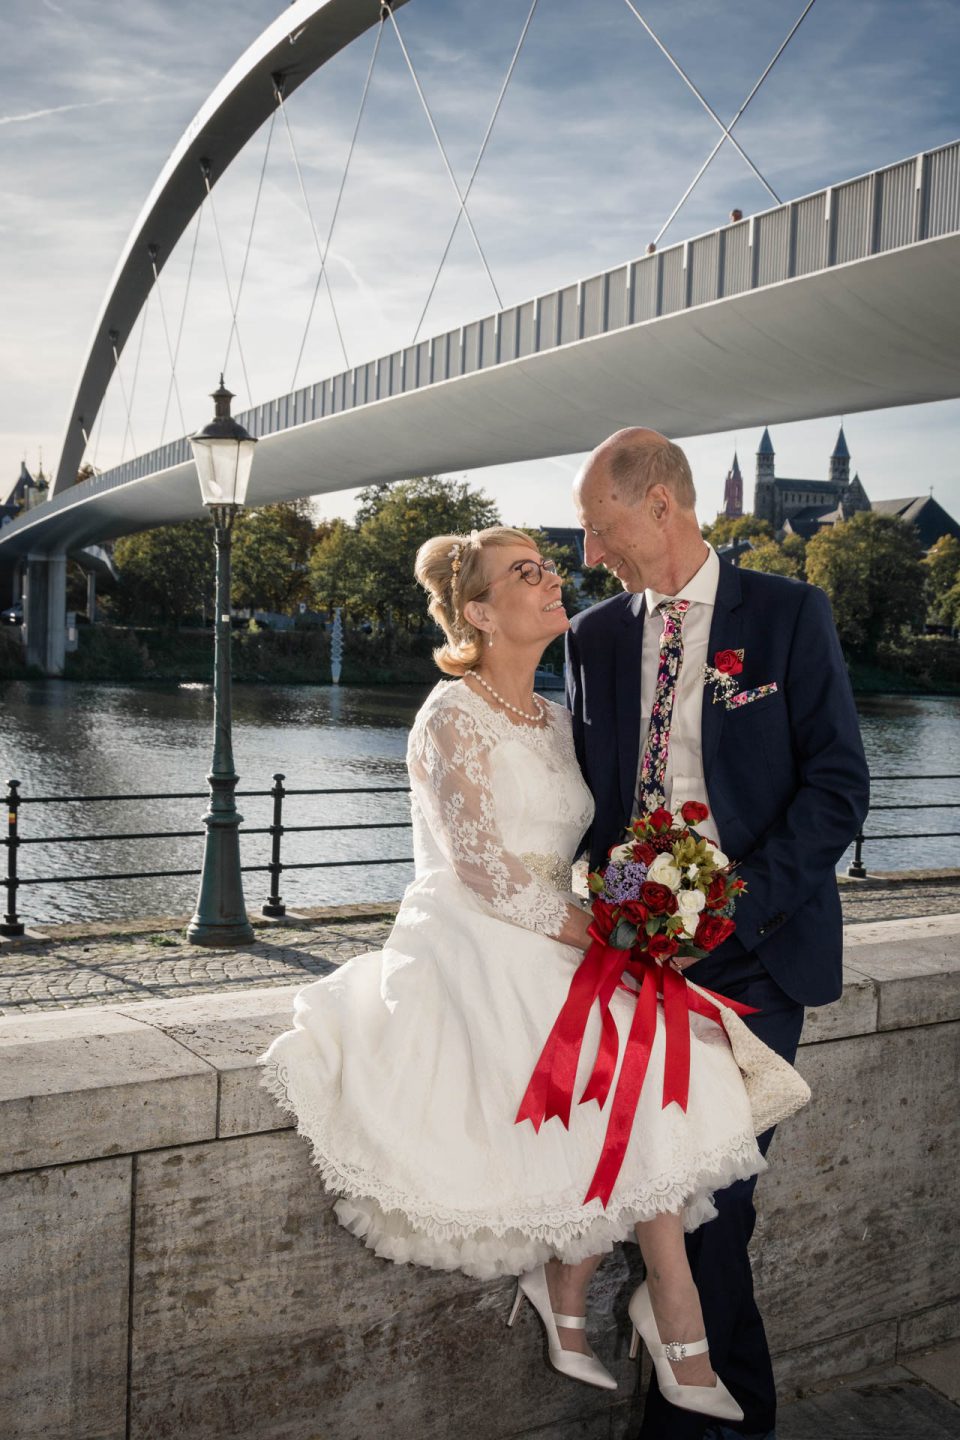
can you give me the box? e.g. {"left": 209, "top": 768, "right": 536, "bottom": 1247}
{"left": 567, "top": 560, "right": 869, "bottom": 1005}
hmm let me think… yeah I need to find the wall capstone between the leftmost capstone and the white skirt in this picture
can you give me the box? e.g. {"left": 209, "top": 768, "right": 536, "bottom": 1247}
{"left": 116, "top": 990, "right": 306, "bottom": 1136}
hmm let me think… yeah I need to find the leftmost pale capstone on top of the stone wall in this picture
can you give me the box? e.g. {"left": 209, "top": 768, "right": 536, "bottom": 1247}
{"left": 0, "top": 1008, "right": 217, "bottom": 1172}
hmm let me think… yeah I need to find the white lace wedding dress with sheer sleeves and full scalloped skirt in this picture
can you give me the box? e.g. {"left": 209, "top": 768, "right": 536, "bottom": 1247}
{"left": 262, "top": 681, "right": 764, "bottom": 1279}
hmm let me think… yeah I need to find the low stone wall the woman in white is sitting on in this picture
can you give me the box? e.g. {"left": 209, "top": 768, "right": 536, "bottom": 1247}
{"left": 0, "top": 914, "right": 960, "bottom": 1440}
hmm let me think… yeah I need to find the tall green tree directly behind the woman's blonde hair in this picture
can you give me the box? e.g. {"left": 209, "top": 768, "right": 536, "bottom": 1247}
{"left": 358, "top": 475, "right": 499, "bottom": 629}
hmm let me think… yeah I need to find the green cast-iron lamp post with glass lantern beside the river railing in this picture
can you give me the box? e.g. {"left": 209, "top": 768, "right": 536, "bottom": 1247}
{"left": 187, "top": 376, "right": 256, "bottom": 946}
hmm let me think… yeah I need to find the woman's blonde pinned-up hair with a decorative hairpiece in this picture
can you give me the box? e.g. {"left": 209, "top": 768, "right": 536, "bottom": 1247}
{"left": 413, "top": 526, "right": 535, "bottom": 675}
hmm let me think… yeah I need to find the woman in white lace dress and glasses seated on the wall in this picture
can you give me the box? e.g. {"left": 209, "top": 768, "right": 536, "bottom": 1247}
{"left": 262, "top": 527, "right": 805, "bottom": 1421}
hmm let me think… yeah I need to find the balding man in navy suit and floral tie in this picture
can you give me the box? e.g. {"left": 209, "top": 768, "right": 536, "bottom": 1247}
{"left": 567, "top": 429, "right": 868, "bottom": 1440}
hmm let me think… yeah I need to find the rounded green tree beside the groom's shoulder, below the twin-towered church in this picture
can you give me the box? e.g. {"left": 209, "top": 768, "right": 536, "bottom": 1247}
{"left": 806, "top": 510, "right": 925, "bottom": 658}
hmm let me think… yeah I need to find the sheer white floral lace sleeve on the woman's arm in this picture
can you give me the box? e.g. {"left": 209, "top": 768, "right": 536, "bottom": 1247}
{"left": 410, "top": 704, "right": 569, "bottom": 939}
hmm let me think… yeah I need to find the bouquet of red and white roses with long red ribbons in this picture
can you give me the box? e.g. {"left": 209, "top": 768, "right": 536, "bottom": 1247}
{"left": 515, "top": 801, "right": 754, "bottom": 1208}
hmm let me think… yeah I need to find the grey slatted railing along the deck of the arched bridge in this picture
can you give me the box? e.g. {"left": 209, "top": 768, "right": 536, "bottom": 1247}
{"left": 5, "top": 141, "right": 960, "bottom": 524}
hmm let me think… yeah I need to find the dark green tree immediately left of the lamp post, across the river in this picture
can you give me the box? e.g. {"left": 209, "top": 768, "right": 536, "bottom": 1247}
{"left": 111, "top": 520, "right": 213, "bottom": 624}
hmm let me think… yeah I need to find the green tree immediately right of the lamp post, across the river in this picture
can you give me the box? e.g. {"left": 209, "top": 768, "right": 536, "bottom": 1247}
{"left": 230, "top": 500, "right": 315, "bottom": 613}
